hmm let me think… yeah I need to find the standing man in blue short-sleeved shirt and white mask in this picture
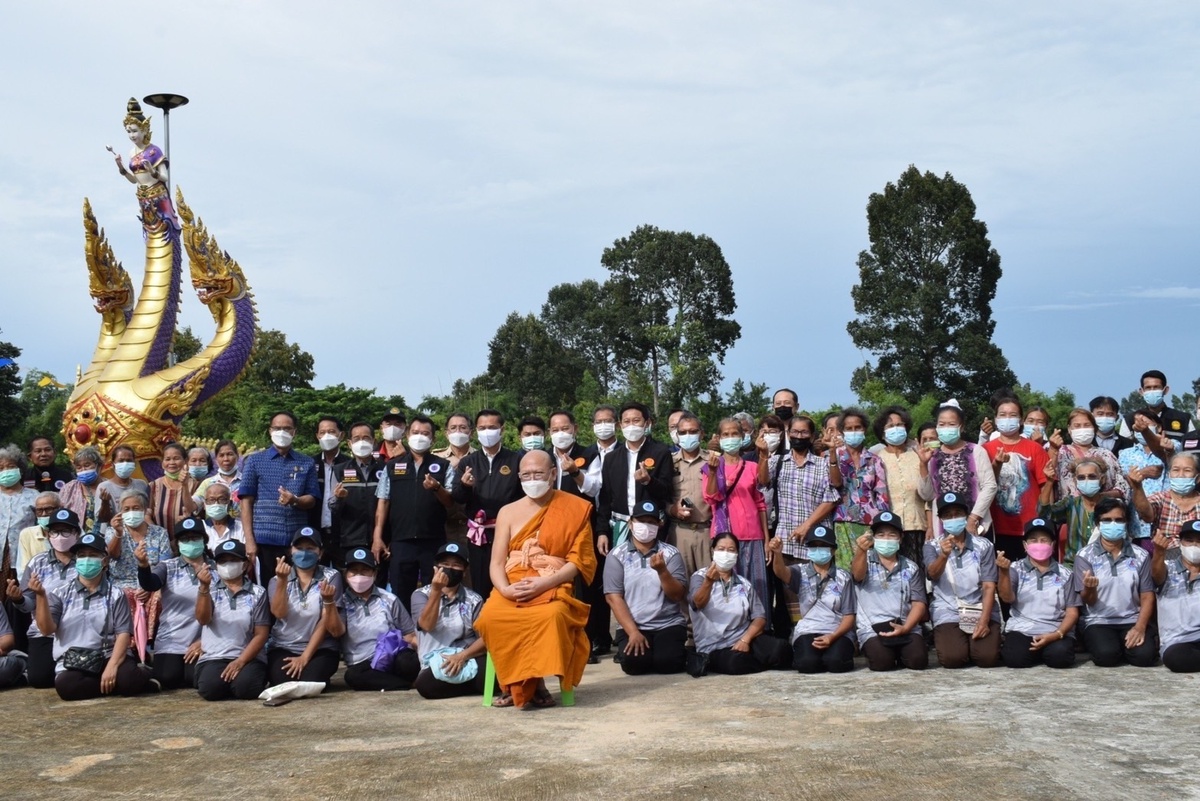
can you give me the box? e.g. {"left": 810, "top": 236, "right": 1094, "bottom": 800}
{"left": 238, "top": 411, "right": 320, "bottom": 586}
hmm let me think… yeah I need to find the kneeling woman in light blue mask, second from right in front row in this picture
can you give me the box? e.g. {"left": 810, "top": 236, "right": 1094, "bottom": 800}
{"left": 1075, "top": 498, "right": 1157, "bottom": 668}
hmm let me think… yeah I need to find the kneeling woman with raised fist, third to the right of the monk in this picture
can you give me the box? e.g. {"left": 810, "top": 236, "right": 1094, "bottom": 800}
{"left": 768, "top": 525, "right": 856, "bottom": 673}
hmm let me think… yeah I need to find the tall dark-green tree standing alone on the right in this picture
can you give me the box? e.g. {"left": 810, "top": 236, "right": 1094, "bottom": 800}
{"left": 846, "top": 165, "right": 1016, "bottom": 408}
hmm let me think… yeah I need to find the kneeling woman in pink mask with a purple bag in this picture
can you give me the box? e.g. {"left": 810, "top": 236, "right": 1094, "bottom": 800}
{"left": 329, "top": 548, "right": 421, "bottom": 691}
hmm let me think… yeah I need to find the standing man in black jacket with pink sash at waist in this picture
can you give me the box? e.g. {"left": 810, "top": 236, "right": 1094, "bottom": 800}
{"left": 451, "top": 409, "right": 524, "bottom": 598}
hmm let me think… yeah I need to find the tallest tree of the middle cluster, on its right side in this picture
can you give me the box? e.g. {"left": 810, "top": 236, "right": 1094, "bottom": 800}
{"left": 600, "top": 225, "right": 742, "bottom": 417}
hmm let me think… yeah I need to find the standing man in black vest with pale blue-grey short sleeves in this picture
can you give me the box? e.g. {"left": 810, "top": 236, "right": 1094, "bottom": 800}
{"left": 371, "top": 415, "right": 454, "bottom": 606}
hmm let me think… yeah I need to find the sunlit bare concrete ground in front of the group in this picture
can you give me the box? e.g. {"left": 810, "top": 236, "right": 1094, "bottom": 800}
{"left": 0, "top": 658, "right": 1200, "bottom": 801}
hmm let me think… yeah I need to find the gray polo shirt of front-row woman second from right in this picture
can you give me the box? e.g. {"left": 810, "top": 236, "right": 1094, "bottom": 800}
{"left": 1074, "top": 540, "right": 1154, "bottom": 626}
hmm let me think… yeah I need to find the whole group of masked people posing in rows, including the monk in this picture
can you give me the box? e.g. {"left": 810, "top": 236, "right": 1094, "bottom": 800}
{"left": 0, "top": 371, "right": 1200, "bottom": 707}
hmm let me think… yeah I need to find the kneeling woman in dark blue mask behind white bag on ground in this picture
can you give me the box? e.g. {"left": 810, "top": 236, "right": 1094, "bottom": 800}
{"left": 266, "top": 526, "right": 342, "bottom": 685}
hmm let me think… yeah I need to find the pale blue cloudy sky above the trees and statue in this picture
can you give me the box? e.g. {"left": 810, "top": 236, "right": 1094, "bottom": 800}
{"left": 0, "top": 1, "right": 1200, "bottom": 408}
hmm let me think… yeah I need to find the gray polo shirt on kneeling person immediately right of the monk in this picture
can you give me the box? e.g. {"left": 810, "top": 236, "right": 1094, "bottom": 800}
{"left": 604, "top": 540, "right": 688, "bottom": 632}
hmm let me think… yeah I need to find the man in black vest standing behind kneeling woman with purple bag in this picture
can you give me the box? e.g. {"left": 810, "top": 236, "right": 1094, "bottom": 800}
{"left": 331, "top": 422, "right": 381, "bottom": 577}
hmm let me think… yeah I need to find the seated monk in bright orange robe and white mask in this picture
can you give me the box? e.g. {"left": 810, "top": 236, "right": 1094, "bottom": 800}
{"left": 475, "top": 451, "right": 596, "bottom": 707}
